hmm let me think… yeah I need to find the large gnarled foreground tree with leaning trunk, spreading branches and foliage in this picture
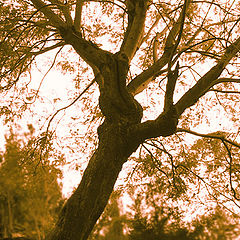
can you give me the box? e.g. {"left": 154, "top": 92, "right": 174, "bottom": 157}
{"left": 0, "top": 0, "right": 240, "bottom": 240}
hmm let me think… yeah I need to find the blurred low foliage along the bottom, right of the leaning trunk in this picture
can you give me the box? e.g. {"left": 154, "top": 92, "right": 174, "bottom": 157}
{"left": 89, "top": 188, "right": 240, "bottom": 240}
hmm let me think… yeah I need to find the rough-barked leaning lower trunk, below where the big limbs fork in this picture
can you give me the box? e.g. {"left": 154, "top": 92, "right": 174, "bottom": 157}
{"left": 48, "top": 121, "right": 142, "bottom": 240}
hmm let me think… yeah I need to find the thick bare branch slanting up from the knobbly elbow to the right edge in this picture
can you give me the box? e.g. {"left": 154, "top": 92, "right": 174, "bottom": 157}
{"left": 176, "top": 38, "right": 240, "bottom": 115}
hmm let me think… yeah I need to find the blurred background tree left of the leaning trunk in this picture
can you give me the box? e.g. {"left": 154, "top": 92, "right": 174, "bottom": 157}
{"left": 0, "top": 125, "right": 63, "bottom": 240}
